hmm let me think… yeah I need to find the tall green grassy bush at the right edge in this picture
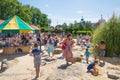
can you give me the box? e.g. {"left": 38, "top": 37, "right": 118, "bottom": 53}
{"left": 92, "top": 18, "right": 120, "bottom": 57}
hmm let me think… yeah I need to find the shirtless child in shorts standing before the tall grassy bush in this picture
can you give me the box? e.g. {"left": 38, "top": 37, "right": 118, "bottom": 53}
{"left": 99, "top": 41, "right": 106, "bottom": 63}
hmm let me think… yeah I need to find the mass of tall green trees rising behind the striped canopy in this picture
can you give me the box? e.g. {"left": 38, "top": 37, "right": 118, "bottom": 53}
{"left": 0, "top": 0, "right": 51, "bottom": 28}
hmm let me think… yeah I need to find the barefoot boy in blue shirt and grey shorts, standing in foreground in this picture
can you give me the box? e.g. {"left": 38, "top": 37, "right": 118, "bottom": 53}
{"left": 30, "top": 43, "right": 44, "bottom": 79}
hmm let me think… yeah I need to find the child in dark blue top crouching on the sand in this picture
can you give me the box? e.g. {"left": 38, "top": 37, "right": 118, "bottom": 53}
{"left": 87, "top": 60, "right": 99, "bottom": 75}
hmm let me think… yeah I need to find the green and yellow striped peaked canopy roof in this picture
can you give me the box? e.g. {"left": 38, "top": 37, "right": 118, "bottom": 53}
{"left": 0, "top": 16, "right": 33, "bottom": 33}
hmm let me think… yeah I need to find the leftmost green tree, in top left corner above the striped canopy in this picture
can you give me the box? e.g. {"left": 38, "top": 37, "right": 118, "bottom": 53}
{"left": 0, "top": 0, "right": 19, "bottom": 20}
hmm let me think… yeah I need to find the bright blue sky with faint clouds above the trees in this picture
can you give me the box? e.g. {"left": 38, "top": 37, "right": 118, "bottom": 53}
{"left": 18, "top": 0, "right": 120, "bottom": 26}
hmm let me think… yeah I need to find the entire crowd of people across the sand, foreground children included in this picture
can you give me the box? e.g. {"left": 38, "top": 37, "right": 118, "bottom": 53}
{"left": 0, "top": 32, "right": 105, "bottom": 78}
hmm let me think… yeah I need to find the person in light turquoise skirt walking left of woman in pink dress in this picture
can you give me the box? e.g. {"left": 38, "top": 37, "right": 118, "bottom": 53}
{"left": 47, "top": 35, "right": 54, "bottom": 57}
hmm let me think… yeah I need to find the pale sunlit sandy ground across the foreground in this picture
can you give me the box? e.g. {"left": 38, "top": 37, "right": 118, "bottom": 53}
{"left": 0, "top": 46, "right": 120, "bottom": 80}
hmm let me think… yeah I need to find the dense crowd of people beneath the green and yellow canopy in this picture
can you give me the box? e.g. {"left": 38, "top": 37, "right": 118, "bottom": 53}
{"left": 0, "top": 34, "right": 35, "bottom": 47}
